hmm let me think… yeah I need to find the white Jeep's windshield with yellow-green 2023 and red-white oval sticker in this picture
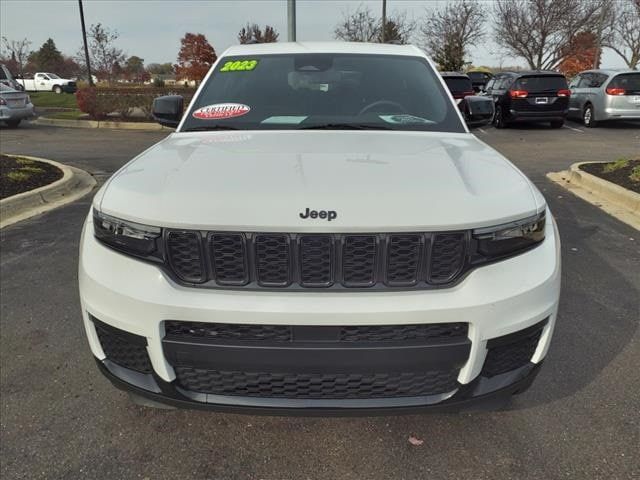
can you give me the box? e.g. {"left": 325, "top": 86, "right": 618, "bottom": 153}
{"left": 181, "top": 54, "right": 465, "bottom": 132}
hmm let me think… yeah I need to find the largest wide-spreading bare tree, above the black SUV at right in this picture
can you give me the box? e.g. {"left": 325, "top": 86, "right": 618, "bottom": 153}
{"left": 494, "top": 0, "right": 603, "bottom": 70}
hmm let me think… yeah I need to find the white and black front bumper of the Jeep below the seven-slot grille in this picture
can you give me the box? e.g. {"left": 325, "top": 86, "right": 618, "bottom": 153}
{"left": 79, "top": 214, "right": 560, "bottom": 414}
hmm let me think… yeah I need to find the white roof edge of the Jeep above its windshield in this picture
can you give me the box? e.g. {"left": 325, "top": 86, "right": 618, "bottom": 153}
{"left": 223, "top": 42, "right": 425, "bottom": 57}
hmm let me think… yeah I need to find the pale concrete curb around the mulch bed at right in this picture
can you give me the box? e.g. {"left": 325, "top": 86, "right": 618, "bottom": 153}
{"left": 547, "top": 162, "right": 640, "bottom": 230}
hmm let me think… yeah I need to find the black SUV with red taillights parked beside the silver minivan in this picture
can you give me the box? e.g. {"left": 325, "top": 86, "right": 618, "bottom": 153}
{"left": 485, "top": 70, "right": 571, "bottom": 128}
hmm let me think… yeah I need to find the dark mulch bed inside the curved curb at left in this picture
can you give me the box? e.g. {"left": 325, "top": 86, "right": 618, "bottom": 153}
{"left": 0, "top": 155, "right": 63, "bottom": 199}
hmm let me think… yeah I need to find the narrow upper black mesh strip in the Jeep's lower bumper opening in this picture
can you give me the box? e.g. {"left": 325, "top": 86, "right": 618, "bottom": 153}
{"left": 164, "top": 320, "right": 468, "bottom": 343}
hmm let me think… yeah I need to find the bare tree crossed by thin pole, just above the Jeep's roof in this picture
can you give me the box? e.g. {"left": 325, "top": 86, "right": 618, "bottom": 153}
{"left": 334, "top": 5, "right": 416, "bottom": 43}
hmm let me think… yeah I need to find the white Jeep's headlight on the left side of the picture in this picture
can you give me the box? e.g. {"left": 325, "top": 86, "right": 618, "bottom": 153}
{"left": 93, "top": 208, "right": 162, "bottom": 257}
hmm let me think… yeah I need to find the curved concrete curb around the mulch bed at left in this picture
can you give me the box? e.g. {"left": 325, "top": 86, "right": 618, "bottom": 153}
{"left": 0, "top": 155, "right": 97, "bottom": 228}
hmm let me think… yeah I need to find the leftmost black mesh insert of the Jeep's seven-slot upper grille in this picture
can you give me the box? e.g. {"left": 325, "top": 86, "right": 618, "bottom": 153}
{"left": 167, "top": 232, "right": 205, "bottom": 283}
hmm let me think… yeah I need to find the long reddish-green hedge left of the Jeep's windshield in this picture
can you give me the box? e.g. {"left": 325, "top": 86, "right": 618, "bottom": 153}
{"left": 76, "top": 86, "right": 195, "bottom": 120}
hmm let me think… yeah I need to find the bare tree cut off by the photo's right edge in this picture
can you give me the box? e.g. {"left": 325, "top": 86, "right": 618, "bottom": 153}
{"left": 603, "top": 0, "right": 640, "bottom": 68}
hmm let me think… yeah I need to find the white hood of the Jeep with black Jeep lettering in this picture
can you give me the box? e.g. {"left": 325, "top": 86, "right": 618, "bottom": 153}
{"left": 94, "top": 131, "right": 543, "bottom": 232}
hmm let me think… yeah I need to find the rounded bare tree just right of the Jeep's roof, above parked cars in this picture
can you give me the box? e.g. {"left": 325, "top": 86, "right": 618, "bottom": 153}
{"left": 420, "top": 0, "right": 486, "bottom": 71}
